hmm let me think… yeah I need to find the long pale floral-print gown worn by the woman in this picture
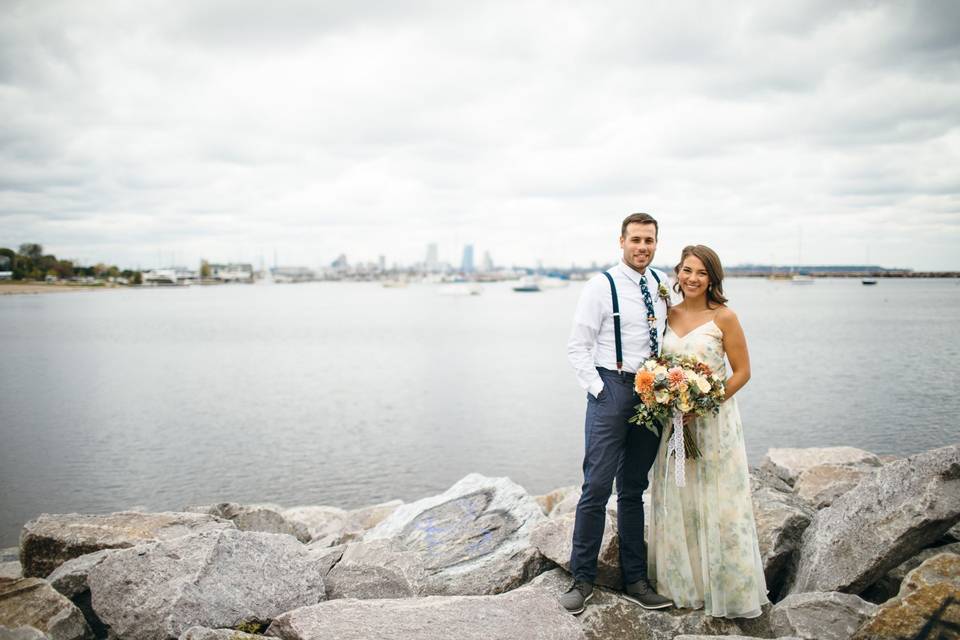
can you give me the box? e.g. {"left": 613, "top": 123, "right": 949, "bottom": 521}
{"left": 648, "top": 320, "right": 769, "bottom": 618}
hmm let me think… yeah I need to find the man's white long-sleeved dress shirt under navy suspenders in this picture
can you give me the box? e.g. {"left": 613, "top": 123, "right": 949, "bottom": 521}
{"left": 567, "top": 261, "right": 670, "bottom": 397}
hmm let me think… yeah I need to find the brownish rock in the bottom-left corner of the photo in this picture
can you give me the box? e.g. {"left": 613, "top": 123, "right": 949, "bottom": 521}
{"left": 0, "top": 578, "right": 93, "bottom": 640}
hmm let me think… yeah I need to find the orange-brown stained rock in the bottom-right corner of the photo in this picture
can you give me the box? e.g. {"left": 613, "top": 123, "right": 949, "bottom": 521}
{"left": 853, "top": 553, "right": 960, "bottom": 640}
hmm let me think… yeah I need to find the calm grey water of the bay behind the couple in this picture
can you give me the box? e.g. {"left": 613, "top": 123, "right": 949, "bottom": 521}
{"left": 0, "top": 279, "right": 960, "bottom": 546}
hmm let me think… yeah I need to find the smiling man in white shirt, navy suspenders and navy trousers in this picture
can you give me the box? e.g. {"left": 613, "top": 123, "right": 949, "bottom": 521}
{"left": 560, "top": 213, "right": 673, "bottom": 614}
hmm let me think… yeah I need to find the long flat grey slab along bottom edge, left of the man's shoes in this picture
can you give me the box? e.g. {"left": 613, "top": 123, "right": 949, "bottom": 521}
{"left": 267, "top": 589, "right": 584, "bottom": 640}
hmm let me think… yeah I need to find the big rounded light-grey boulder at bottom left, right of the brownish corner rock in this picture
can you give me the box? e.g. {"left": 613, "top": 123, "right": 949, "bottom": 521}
{"left": 87, "top": 529, "right": 325, "bottom": 640}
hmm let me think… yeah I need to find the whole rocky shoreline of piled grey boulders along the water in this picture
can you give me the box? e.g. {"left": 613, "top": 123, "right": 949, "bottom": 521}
{"left": 0, "top": 445, "right": 960, "bottom": 640}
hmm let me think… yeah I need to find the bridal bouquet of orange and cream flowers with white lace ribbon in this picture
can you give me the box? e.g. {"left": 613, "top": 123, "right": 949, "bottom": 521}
{"left": 630, "top": 355, "right": 724, "bottom": 458}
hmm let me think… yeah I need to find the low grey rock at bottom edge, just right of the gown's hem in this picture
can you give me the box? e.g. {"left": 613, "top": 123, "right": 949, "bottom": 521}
{"left": 770, "top": 591, "right": 877, "bottom": 640}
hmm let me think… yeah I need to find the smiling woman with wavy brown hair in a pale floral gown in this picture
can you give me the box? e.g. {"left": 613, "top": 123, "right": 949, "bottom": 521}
{"left": 648, "top": 245, "right": 769, "bottom": 618}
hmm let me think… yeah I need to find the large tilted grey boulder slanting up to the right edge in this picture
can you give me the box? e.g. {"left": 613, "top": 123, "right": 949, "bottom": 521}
{"left": 789, "top": 445, "right": 960, "bottom": 593}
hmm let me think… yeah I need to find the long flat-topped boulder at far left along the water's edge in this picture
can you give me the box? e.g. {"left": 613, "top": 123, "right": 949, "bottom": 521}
{"left": 20, "top": 511, "right": 235, "bottom": 578}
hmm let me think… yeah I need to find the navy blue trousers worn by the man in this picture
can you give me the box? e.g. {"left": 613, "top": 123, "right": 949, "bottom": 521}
{"left": 570, "top": 368, "right": 660, "bottom": 584}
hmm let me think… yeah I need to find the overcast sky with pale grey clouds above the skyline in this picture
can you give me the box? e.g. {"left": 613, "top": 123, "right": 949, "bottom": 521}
{"left": 0, "top": 0, "right": 960, "bottom": 269}
